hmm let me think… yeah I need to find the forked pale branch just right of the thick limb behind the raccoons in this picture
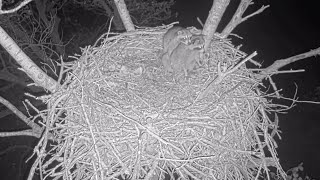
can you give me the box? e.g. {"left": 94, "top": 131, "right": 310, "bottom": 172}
{"left": 221, "top": 0, "right": 269, "bottom": 38}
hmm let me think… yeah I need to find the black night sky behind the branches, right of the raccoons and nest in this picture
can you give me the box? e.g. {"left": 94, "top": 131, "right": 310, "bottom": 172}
{"left": 175, "top": 0, "right": 320, "bottom": 179}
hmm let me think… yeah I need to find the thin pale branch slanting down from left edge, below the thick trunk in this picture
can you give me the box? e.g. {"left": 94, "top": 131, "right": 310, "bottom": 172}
{"left": 0, "top": 96, "right": 42, "bottom": 135}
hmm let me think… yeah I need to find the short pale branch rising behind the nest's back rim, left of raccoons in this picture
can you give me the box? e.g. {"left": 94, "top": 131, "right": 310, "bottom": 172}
{"left": 114, "top": 0, "right": 135, "bottom": 31}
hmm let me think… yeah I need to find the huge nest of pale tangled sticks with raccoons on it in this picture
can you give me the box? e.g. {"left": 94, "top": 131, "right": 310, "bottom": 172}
{"left": 32, "top": 26, "right": 285, "bottom": 179}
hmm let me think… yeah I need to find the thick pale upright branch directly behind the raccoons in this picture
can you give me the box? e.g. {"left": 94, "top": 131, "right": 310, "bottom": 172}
{"left": 202, "top": 0, "right": 230, "bottom": 49}
